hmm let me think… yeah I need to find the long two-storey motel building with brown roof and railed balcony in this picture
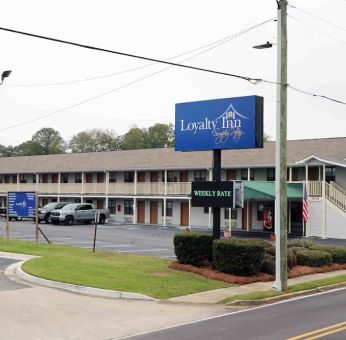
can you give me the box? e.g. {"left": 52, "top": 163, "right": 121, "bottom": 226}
{"left": 0, "top": 137, "right": 346, "bottom": 239}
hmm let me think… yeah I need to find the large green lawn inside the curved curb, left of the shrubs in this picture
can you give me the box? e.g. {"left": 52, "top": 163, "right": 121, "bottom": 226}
{"left": 0, "top": 238, "right": 230, "bottom": 299}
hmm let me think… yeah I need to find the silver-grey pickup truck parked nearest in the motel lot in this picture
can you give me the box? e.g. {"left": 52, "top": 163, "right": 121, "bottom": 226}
{"left": 50, "top": 203, "right": 109, "bottom": 225}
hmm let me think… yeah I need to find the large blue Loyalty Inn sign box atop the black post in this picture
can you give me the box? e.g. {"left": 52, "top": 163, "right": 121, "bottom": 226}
{"left": 175, "top": 96, "right": 263, "bottom": 151}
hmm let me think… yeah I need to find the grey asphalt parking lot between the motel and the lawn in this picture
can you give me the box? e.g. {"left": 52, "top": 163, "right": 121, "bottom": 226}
{"left": 0, "top": 219, "right": 181, "bottom": 258}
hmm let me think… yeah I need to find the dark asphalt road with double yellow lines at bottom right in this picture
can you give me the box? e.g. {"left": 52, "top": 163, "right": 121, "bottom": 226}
{"left": 129, "top": 288, "right": 346, "bottom": 340}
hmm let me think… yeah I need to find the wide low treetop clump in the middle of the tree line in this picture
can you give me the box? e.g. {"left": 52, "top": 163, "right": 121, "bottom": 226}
{"left": 69, "top": 129, "right": 120, "bottom": 152}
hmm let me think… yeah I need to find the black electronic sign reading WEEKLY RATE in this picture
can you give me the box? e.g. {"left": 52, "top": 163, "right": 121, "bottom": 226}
{"left": 191, "top": 181, "right": 234, "bottom": 208}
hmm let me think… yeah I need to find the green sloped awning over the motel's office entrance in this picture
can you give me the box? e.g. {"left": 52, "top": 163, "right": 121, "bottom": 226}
{"left": 244, "top": 181, "right": 303, "bottom": 201}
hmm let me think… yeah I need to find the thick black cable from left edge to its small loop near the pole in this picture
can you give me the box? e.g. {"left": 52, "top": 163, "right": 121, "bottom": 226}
{"left": 0, "top": 27, "right": 263, "bottom": 84}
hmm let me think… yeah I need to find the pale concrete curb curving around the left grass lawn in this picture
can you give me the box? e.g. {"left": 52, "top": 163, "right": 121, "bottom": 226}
{"left": 1, "top": 254, "right": 158, "bottom": 301}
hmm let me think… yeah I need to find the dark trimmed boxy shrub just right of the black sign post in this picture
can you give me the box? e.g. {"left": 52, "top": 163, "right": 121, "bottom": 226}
{"left": 213, "top": 239, "right": 264, "bottom": 275}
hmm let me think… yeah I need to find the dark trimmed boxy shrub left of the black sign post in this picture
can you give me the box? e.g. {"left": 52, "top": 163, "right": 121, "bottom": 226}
{"left": 173, "top": 232, "right": 213, "bottom": 266}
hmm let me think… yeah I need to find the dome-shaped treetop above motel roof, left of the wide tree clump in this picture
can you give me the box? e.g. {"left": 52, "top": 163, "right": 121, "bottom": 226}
{"left": 31, "top": 128, "right": 66, "bottom": 155}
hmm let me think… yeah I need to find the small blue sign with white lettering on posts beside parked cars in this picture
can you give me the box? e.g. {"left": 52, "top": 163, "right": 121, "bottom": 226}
{"left": 7, "top": 191, "right": 36, "bottom": 217}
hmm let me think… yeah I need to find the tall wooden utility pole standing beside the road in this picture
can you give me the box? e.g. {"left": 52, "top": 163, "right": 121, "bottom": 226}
{"left": 273, "top": 0, "right": 287, "bottom": 291}
